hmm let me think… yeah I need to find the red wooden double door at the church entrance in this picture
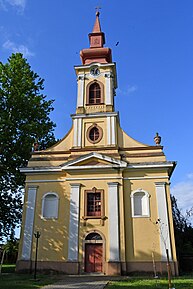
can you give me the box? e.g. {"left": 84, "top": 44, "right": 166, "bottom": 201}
{"left": 85, "top": 244, "right": 103, "bottom": 273}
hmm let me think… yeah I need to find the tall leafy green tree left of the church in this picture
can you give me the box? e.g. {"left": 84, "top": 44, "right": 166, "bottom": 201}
{"left": 0, "top": 53, "right": 55, "bottom": 240}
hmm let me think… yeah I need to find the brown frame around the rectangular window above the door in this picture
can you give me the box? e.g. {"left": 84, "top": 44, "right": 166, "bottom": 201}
{"left": 84, "top": 187, "right": 105, "bottom": 219}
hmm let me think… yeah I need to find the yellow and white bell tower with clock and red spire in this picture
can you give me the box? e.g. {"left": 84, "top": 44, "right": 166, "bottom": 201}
{"left": 72, "top": 12, "right": 118, "bottom": 149}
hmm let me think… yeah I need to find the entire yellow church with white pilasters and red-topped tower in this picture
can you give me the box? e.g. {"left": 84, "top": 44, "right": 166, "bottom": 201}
{"left": 16, "top": 12, "right": 178, "bottom": 275}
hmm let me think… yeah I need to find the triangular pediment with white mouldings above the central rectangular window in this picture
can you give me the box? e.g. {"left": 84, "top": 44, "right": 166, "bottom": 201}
{"left": 61, "top": 152, "right": 127, "bottom": 170}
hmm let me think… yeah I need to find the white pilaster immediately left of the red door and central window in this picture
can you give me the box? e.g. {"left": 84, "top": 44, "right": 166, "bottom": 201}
{"left": 68, "top": 184, "right": 81, "bottom": 261}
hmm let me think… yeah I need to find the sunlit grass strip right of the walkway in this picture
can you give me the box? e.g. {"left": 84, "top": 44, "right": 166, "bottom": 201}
{"left": 107, "top": 277, "right": 193, "bottom": 289}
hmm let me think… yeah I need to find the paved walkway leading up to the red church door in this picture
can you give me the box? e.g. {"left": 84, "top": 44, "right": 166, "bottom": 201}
{"left": 42, "top": 276, "right": 123, "bottom": 289}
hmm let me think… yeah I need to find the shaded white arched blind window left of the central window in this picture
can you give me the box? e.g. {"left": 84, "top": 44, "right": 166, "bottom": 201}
{"left": 42, "top": 193, "right": 59, "bottom": 219}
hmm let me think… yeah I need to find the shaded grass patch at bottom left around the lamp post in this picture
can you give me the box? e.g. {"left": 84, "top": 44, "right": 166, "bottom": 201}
{"left": 0, "top": 273, "right": 58, "bottom": 289}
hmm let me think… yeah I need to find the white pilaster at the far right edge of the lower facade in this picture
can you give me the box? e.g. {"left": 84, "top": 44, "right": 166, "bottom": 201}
{"left": 155, "top": 182, "right": 171, "bottom": 261}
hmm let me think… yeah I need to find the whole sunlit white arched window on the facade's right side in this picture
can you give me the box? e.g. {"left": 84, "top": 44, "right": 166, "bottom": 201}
{"left": 131, "top": 189, "right": 150, "bottom": 217}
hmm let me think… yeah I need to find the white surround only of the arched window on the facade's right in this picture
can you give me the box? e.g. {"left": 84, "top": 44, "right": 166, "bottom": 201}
{"left": 130, "top": 189, "right": 150, "bottom": 218}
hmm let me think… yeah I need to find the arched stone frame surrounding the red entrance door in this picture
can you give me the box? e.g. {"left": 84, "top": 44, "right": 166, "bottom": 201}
{"left": 81, "top": 230, "right": 106, "bottom": 274}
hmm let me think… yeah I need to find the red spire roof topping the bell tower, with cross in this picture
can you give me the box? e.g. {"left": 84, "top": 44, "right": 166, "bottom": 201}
{"left": 80, "top": 11, "right": 112, "bottom": 64}
